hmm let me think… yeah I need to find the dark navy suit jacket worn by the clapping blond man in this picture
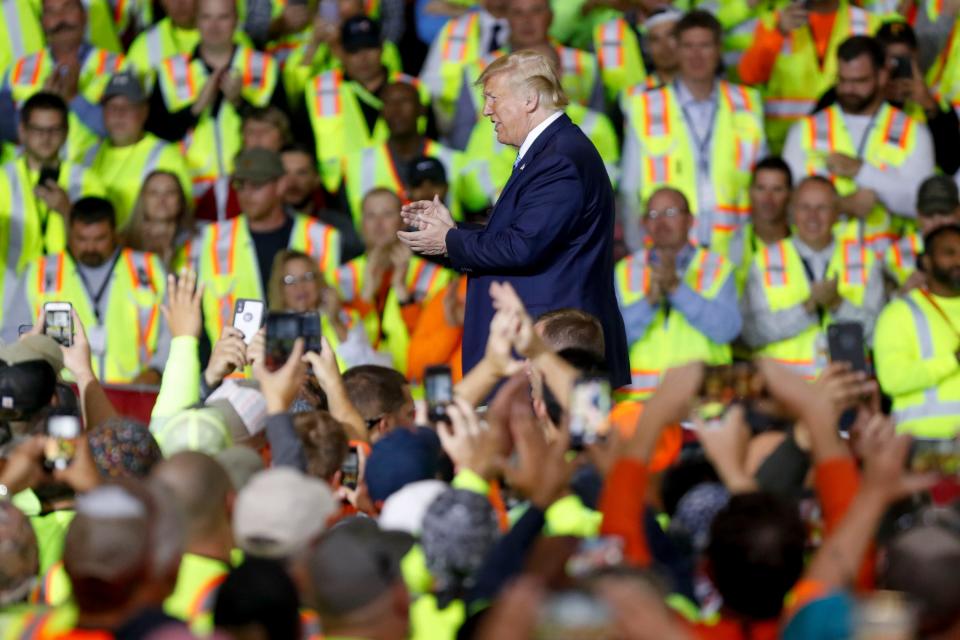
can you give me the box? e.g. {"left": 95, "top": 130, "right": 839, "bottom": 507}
{"left": 447, "top": 115, "right": 630, "bottom": 387}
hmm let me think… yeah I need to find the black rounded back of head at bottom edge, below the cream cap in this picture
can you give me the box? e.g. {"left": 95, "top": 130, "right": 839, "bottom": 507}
{"left": 213, "top": 557, "right": 300, "bottom": 640}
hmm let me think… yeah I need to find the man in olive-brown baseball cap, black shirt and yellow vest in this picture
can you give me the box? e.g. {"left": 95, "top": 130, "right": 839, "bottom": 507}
{"left": 188, "top": 149, "right": 340, "bottom": 343}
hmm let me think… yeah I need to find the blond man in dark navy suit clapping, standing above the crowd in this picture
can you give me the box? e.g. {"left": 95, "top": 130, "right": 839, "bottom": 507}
{"left": 399, "top": 50, "right": 630, "bottom": 387}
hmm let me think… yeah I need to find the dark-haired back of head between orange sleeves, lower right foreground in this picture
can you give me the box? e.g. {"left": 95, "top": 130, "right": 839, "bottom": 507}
{"left": 706, "top": 492, "right": 806, "bottom": 620}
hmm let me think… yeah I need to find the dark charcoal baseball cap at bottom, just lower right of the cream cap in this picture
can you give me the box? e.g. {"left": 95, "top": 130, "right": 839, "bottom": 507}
{"left": 310, "top": 516, "right": 413, "bottom": 618}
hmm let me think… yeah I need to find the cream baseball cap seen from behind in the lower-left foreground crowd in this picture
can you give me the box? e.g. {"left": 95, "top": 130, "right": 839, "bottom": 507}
{"left": 233, "top": 467, "right": 337, "bottom": 558}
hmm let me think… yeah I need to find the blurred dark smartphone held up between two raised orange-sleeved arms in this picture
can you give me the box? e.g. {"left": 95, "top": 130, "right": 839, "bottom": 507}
{"left": 694, "top": 362, "right": 792, "bottom": 433}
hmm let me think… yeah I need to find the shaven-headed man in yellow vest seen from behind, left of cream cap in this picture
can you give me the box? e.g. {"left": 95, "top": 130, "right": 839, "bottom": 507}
{"left": 152, "top": 451, "right": 234, "bottom": 631}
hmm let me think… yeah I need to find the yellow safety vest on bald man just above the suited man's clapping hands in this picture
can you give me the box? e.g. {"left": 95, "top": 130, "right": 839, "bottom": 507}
{"left": 344, "top": 140, "right": 462, "bottom": 229}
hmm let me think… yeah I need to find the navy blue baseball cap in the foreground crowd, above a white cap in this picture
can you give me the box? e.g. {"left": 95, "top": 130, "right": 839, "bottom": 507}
{"left": 364, "top": 427, "right": 440, "bottom": 502}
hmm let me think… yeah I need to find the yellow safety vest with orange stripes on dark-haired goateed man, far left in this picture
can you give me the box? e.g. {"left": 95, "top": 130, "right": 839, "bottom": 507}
{"left": 24, "top": 249, "right": 166, "bottom": 384}
